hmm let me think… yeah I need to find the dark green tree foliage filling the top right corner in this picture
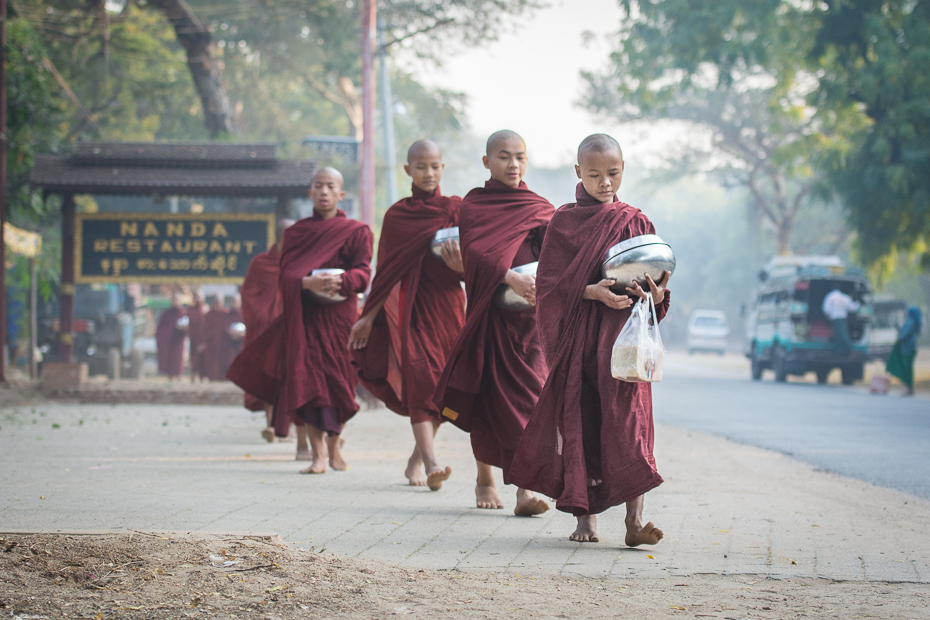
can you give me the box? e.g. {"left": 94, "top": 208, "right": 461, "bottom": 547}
{"left": 810, "top": 0, "right": 930, "bottom": 270}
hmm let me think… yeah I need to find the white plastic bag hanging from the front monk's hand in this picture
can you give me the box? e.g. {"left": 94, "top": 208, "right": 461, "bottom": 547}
{"left": 610, "top": 293, "right": 665, "bottom": 383}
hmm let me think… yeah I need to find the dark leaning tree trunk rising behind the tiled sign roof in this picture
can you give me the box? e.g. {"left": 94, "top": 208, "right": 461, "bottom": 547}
{"left": 148, "top": 0, "right": 236, "bottom": 138}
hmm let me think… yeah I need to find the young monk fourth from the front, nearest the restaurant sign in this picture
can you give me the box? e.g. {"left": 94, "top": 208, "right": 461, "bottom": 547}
{"left": 229, "top": 168, "right": 373, "bottom": 474}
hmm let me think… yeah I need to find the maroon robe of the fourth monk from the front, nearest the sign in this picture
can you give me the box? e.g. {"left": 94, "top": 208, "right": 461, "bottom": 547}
{"left": 228, "top": 211, "right": 372, "bottom": 437}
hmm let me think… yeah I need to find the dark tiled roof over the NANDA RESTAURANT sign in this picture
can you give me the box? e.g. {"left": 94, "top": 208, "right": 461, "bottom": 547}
{"left": 30, "top": 142, "right": 317, "bottom": 198}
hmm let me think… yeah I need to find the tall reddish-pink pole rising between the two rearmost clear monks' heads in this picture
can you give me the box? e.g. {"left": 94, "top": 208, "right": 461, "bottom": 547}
{"left": 359, "top": 0, "right": 378, "bottom": 229}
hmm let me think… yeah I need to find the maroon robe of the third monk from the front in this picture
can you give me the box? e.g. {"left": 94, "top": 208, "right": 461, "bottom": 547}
{"left": 353, "top": 185, "right": 465, "bottom": 424}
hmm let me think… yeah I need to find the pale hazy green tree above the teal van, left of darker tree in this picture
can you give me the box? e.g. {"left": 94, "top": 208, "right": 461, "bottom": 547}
{"left": 584, "top": 0, "right": 836, "bottom": 254}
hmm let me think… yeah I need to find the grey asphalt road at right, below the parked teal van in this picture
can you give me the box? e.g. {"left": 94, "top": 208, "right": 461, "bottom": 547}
{"left": 653, "top": 354, "right": 930, "bottom": 500}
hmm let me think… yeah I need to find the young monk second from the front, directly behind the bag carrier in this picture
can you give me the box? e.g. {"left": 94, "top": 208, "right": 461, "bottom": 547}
{"left": 436, "top": 131, "right": 554, "bottom": 515}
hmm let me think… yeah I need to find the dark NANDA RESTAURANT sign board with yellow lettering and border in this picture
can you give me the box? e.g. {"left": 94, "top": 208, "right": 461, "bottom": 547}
{"left": 75, "top": 213, "right": 274, "bottom": 284}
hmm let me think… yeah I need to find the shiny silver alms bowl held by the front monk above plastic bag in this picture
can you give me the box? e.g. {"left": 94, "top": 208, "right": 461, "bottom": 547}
{"left": 601, "top": 235, "right": 675, "bottom": 295}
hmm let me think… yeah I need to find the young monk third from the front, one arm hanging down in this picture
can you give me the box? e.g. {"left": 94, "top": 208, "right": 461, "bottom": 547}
{"left": 349, "top": 140, "right": 465, "bottom": 491}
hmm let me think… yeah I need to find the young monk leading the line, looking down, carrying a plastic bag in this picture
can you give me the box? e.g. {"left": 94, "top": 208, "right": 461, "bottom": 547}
{"left": 510, "top": 134, "right": 670, "bottom": 547}
